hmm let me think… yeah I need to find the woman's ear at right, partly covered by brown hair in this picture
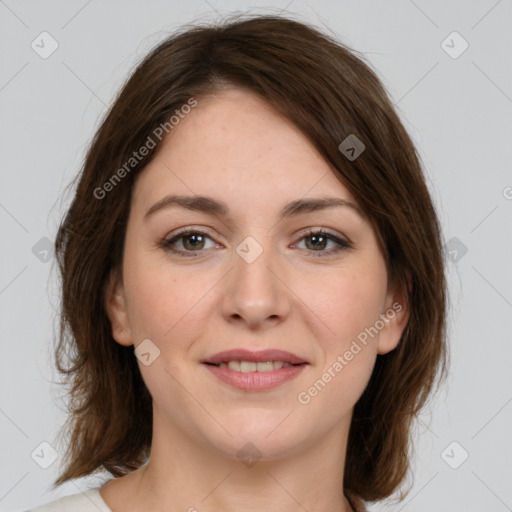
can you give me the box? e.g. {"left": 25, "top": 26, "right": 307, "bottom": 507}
{"left": 377, "top": 280, "right": 412, "bottom": 355}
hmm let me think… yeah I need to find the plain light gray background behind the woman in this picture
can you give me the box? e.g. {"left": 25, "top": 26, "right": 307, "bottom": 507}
{"left": 0, "top": 0, "right": 512, "bottom": 512}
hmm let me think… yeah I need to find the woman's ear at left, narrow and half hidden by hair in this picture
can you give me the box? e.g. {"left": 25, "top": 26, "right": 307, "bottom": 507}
{"left": 105, "top": 270, "right": 133, "bottom": 346}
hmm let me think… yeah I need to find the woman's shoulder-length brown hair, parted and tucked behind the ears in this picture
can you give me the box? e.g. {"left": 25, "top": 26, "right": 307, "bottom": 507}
{"left": 54, "top": 16, "right": 447, "bottom": 508}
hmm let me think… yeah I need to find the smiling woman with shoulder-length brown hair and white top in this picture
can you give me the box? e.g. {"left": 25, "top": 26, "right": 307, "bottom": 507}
{"left": 28, "top": 16, "right": 446, "bottom": 512}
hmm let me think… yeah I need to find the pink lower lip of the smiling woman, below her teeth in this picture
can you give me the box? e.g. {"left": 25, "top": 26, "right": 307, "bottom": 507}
{"left": 204, "top": 364, "right": 306, "bottom": 391}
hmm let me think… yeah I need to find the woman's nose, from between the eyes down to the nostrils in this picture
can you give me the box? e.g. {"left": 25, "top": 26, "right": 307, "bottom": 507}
{"left": 222, "top": 237, "right": 291, "bottom": 330}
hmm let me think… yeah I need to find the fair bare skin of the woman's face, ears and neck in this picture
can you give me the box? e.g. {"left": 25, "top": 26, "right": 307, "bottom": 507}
{"left": 100, "top": 89, "right": 408, "bottom": 512}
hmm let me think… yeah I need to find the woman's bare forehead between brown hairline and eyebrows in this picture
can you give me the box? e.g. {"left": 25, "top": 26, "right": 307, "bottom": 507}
{"left": 130, "top": 89, "right": 355, "bottom": 214}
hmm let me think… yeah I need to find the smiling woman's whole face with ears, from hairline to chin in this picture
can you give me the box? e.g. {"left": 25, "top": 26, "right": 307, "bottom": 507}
{"left": 107, "top": 86, "right": 407, "bottom": 458}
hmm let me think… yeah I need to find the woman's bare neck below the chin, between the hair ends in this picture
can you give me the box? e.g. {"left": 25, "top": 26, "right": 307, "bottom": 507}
{"left": 117, "top": 410, "right": 352, "bottom": 512}
